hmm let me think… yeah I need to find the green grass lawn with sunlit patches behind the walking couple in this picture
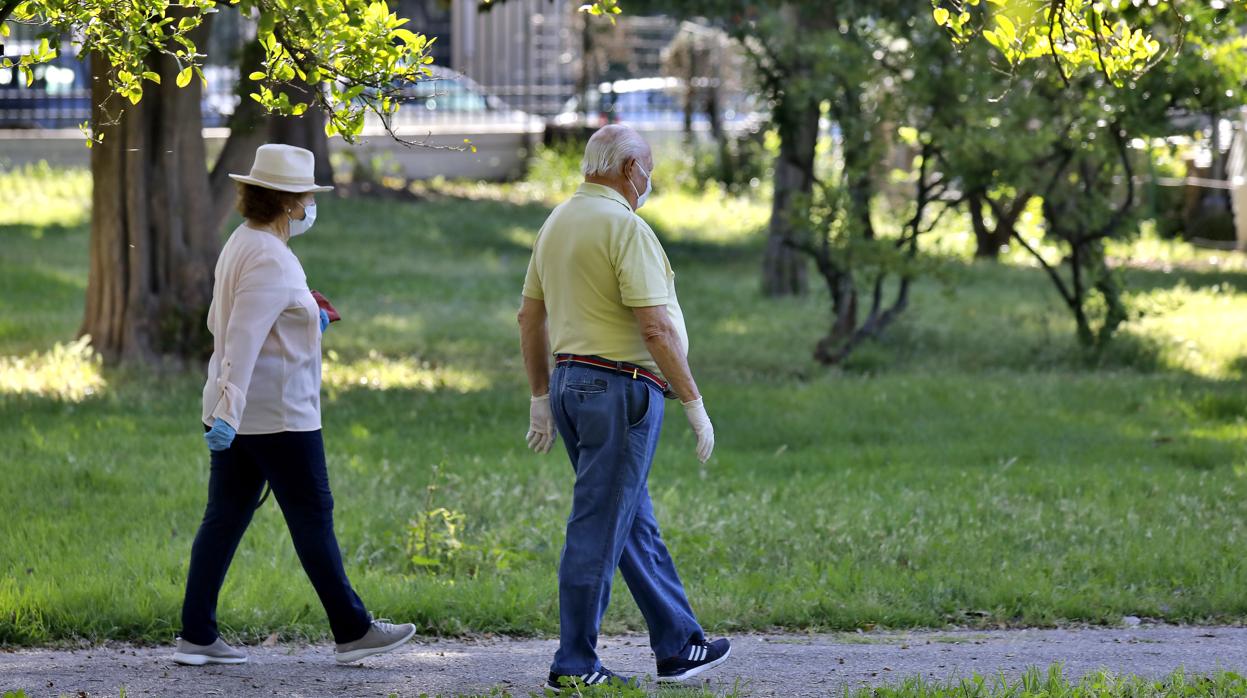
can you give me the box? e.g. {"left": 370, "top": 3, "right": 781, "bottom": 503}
{"left": 0, "top": 159, "right": 1247, "bottom": 646}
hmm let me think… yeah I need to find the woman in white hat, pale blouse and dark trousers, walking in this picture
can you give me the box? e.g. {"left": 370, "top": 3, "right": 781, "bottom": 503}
{"left": 173, "top": 145, "right": 415, "bottom": 666}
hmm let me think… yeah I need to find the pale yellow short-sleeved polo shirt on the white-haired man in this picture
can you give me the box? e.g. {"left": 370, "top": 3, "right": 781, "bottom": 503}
{"left": 524, "top": 182, "right": 688, "bottom": 371}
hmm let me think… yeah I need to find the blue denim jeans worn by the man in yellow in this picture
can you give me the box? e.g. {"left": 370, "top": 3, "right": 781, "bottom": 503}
{"left": 550, "top": 366, "right": 702, "bottom": 674}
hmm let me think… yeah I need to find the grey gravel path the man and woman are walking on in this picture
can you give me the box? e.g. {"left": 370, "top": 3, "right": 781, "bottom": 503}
{"left": 0, "top": 626, "right": 1247, "bottom": 697}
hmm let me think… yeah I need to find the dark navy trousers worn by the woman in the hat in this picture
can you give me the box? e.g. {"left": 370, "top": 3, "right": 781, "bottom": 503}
{"left": 182, "top": 430, "right": 372, "bottom": 644}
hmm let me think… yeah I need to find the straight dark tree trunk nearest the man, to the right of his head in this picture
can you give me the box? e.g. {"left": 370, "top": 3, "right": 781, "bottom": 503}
{"left": 762, "top": 96, "right": 819, "bottom": 297}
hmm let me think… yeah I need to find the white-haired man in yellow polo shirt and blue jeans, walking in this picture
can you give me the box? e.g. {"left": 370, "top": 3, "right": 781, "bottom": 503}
{"left": 519, "top": 125, "right": 731, "bottom": 688}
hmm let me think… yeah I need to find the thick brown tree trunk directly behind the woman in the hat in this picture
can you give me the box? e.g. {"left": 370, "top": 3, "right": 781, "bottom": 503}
{"left": 81, "top": 22, "right": 218, "bottom": 363}
